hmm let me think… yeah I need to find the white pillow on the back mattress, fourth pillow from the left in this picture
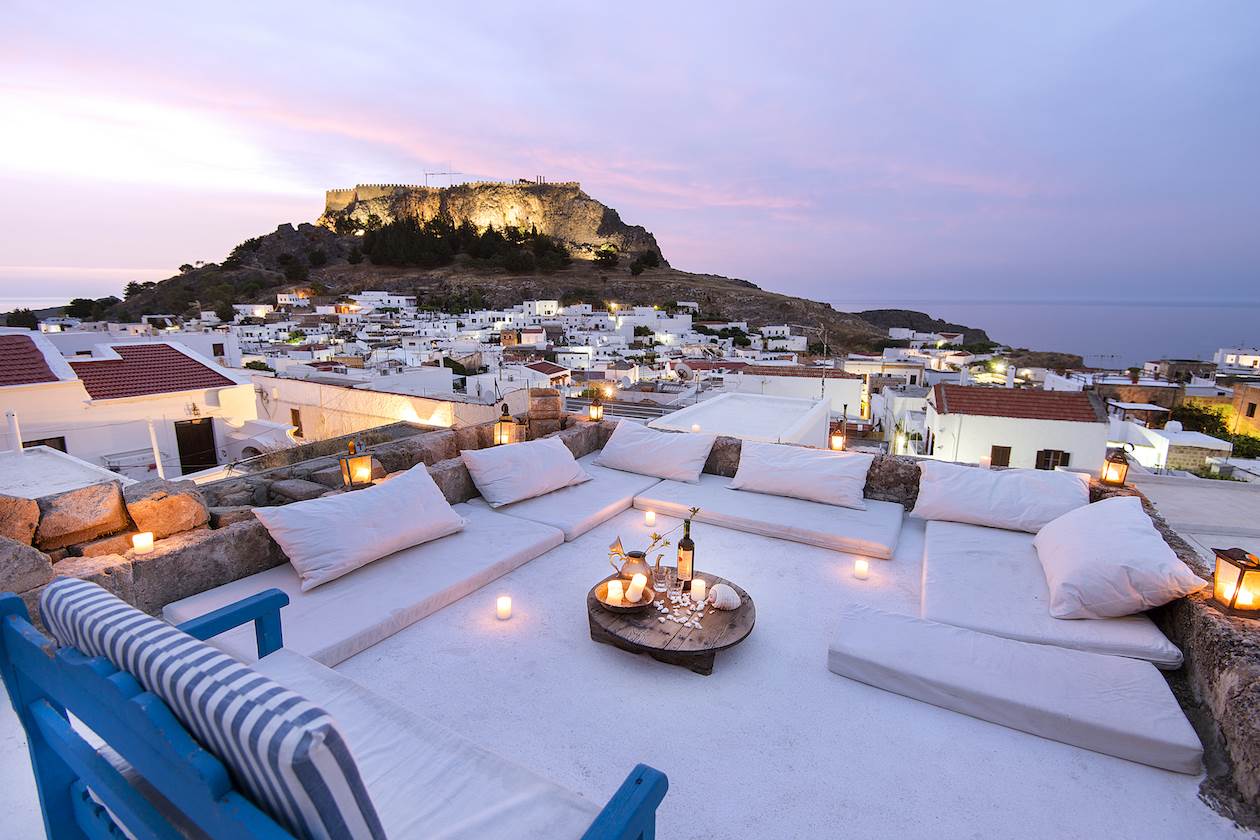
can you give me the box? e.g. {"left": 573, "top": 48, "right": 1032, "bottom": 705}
{"left": 730, "top": 441, "right": 874, "bottom": 510}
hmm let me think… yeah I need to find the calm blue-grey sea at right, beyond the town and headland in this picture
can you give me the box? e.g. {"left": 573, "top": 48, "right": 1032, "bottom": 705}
{"left": 828, "top": 298, "right": 1260, "bottom": 368}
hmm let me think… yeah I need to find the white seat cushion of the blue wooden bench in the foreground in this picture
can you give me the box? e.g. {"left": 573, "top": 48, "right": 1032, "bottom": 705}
{"left": 255, "top": 649, "right": 600, "bottom": 840}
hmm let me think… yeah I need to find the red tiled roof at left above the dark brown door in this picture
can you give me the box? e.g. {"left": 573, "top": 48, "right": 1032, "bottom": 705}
{"left": 71, "top": 344, "right": 236, "bottom": 399}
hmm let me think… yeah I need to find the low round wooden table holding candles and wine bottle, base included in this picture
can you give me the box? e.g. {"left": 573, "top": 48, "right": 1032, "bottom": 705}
{"left": 586, "top": 572, "right": 757, "bottom": 675}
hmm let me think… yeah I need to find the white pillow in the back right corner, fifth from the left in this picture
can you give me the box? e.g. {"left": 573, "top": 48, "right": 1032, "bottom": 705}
{"left": 911, "top": 461, "right": 1090, "bottom": 534}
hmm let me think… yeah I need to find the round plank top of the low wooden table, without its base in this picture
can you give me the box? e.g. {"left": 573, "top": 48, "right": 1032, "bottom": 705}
{"left": 586, "top": 572, "right": 757, "bottom": 654}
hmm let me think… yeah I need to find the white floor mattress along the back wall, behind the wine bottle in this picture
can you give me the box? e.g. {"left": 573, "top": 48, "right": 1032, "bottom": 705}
{"left": 634, "top": 475, "right": 905, "bottom": 559}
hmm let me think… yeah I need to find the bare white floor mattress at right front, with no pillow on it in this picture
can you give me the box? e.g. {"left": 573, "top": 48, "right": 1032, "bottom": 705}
{"left": 828, "top": 604, "right": 1203, "bottom": 775}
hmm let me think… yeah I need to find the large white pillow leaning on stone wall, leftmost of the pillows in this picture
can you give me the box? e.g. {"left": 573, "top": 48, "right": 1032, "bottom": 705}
{"left": 253, "top": 463, "right": 465, "bottom": 592}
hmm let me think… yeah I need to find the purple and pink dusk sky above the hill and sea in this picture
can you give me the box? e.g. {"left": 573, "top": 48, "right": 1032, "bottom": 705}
{"left": 0, "top": 0, "right": 1260, "bottom": 301}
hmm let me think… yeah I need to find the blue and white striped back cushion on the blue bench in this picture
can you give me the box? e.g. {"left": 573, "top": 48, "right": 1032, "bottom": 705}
{"left": 39, "top": 578, "right": 384, "bottom": 839}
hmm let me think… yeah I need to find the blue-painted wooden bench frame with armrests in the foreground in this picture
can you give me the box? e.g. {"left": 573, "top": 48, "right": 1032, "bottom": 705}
{"left": 0, "top": 589, "right": 669, "bottom": 840}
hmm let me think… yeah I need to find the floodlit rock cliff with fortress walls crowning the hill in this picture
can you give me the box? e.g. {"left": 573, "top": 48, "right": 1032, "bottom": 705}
{"left": 316, "top": 181, "right": 663, "bottom": 259}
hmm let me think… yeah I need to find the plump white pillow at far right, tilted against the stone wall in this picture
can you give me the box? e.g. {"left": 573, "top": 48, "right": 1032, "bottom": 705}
{"left": 1032, "top": 496, "right": 1207, "bottom": 618}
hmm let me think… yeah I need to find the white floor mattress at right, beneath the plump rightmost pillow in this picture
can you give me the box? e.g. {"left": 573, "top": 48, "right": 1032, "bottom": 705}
{"left": 919, "top": 521, "right": 1182, "bottom": 669}
